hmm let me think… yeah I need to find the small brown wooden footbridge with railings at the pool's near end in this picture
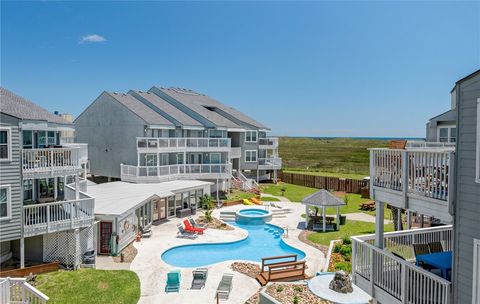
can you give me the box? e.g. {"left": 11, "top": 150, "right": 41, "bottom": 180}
{"left": 256, "top": 255, "right": 306, "bottom": 286}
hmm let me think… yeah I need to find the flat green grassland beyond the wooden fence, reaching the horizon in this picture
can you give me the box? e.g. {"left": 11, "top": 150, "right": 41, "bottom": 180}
{"left": 278, "top": 137, "right": 388, "bottom": 178}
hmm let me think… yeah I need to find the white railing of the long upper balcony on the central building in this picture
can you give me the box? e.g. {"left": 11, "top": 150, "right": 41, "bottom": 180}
{"left": 137, "top": 137, "right": 231, "bottom": 152}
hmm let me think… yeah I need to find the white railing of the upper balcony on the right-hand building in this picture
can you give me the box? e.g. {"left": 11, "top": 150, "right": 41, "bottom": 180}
{"left": 370, "top": 149, "right": 454, "bottom": 201}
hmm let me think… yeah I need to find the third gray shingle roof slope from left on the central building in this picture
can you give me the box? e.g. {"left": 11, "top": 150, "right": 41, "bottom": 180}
{"left": 153, "top": 87, "right": 244, "bottom": 128}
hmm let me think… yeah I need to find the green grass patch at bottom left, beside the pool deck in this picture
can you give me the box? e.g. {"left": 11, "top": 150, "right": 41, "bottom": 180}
{"left": 35, "top": 269, "right": 140, "bottom": 304}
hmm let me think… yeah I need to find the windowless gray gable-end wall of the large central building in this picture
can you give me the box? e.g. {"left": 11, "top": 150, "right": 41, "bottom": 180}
{"left": 74, "top": 93, "right": 146, "bottom": 178}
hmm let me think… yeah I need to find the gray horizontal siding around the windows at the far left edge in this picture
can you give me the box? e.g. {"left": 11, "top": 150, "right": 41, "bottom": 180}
{"left": 0, "top": 113, "right": 22, "bottom": 241}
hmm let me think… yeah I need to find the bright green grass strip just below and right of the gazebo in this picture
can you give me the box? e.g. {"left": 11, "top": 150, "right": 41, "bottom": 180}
{"left": 307, "top": 220, "right": 393, "bottom": 246}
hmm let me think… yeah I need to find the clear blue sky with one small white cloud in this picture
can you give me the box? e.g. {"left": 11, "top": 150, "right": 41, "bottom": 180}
{"left": 1, "top": 2, "right": 480, "bottom": 137}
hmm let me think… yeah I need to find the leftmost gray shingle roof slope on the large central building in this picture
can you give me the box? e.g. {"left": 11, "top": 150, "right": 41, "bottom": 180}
{"left": 106, "top": 92, "right": 175, "bottom": 127}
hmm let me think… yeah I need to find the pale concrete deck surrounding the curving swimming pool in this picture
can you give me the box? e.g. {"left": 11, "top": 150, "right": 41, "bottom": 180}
{"left": 97, "top": 202, "right": 325, "bottom": 304}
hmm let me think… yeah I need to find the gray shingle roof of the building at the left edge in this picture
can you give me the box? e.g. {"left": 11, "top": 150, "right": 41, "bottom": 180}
{"left": 0, "top": 87, "right": 72, "bottom": 125}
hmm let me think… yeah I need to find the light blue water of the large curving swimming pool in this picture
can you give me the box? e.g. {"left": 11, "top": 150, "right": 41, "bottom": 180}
{"left": 162, "top": 223, "right": 305, "bottom": 268}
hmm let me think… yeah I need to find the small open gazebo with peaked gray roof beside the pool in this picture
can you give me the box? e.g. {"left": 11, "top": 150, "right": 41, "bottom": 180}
{"left": 302, "top": 189, "right": 345, "bottom": 232}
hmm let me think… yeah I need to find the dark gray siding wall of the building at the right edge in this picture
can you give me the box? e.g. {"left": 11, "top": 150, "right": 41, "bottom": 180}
{"left": 452, "top": 75, "right": 480, "bottom": 303}
